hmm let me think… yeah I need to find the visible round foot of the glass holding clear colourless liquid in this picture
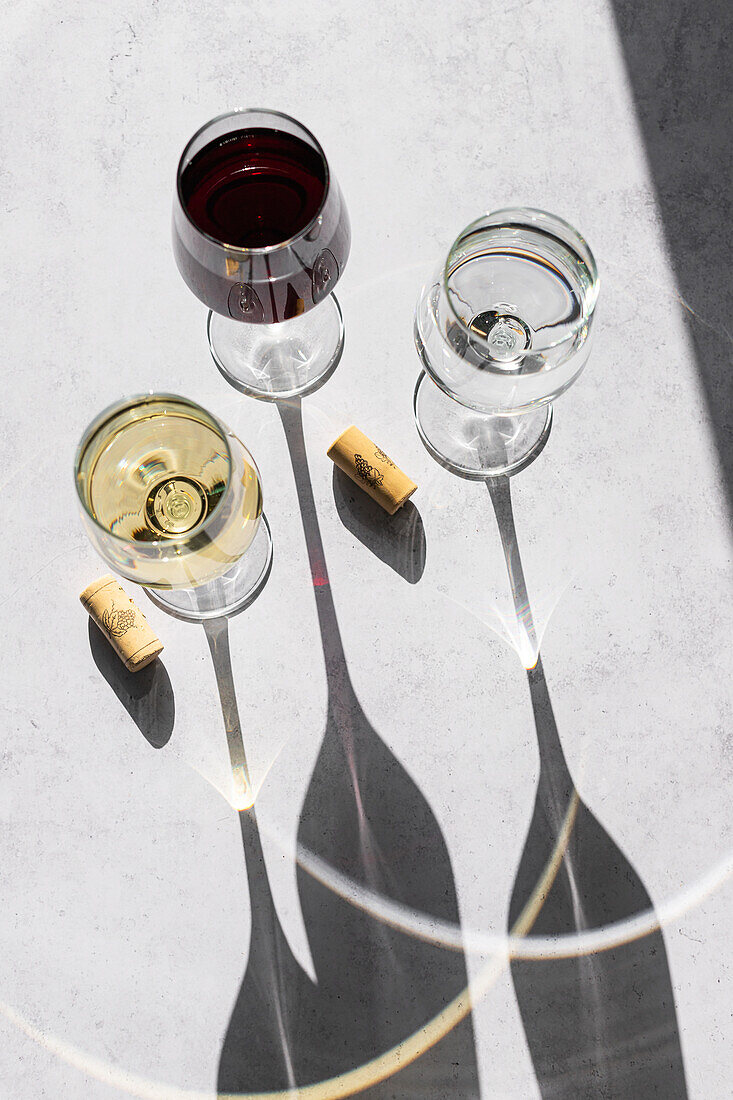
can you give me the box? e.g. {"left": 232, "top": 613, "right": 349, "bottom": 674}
{"left": 413, "top": 372, "right": 553, "bottom": 481}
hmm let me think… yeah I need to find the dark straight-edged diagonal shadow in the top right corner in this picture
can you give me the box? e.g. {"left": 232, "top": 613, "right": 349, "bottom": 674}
{"left": 612, "top": 0, "right": 733, "bottom": 514}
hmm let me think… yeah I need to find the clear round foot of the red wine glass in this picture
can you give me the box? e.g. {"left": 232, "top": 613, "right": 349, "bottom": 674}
{"left": 207, "top": 294, "right": 343, "bottom": 402}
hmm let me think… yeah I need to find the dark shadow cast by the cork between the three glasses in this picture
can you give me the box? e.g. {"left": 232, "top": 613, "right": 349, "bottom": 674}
{"left": 333, "top": 466, "right": 425, "bottom": 584}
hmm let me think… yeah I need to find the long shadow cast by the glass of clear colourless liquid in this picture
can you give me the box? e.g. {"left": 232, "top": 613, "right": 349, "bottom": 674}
{"left": 488, "top": 477, "right": 687, "bottom": 1100}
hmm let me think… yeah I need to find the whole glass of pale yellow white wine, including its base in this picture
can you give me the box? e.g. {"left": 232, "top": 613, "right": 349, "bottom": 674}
{"left": 74, "top": 394, "right": 272, "bottom": 622}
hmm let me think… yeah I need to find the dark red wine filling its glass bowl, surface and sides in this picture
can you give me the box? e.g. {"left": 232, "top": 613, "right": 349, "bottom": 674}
{"left": 173, "top": 128, "right": 351, "bottom": 325}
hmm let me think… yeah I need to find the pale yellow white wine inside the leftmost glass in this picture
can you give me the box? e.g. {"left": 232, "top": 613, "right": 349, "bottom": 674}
{"left": 79, "top": 397, "right": 262, "bottom": 587}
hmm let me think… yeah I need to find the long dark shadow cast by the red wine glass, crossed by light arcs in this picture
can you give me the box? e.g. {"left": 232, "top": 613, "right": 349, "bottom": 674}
{"left": 265, "top": 400, "right": 479, "bottom": 1100}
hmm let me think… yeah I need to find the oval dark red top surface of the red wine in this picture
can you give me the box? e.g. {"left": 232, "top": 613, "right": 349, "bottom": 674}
{"left": 180, "top": 129, "right": 326, "bottom": 249}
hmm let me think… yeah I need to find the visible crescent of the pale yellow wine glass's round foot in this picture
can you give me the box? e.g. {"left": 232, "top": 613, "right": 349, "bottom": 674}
{"left": 145, "top": 514, "right": 272, "bottom": 623}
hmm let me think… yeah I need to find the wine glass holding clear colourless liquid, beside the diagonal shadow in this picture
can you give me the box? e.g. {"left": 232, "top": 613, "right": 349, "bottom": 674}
{"left": 414, "top": 208, "right": 599, "bottom": 481}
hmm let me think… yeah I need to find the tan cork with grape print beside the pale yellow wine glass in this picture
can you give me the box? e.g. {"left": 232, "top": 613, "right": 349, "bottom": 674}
{"left": 79, "top": 573, "right": 163, "bottom": 672}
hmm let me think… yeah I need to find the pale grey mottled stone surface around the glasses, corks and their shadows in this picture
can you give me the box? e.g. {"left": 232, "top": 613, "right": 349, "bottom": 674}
{"left": 0, "top": 0, "right": 733, "bottom": 1100}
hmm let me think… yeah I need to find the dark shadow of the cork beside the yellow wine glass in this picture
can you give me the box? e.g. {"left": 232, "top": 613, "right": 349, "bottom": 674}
{"left": 89, "top": 619, "right": 176, "bottom": 749}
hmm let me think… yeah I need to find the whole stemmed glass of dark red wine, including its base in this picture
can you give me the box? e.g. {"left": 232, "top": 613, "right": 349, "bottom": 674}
{"left": 173, "top": 110, "right": 351, "bottom": 400}
